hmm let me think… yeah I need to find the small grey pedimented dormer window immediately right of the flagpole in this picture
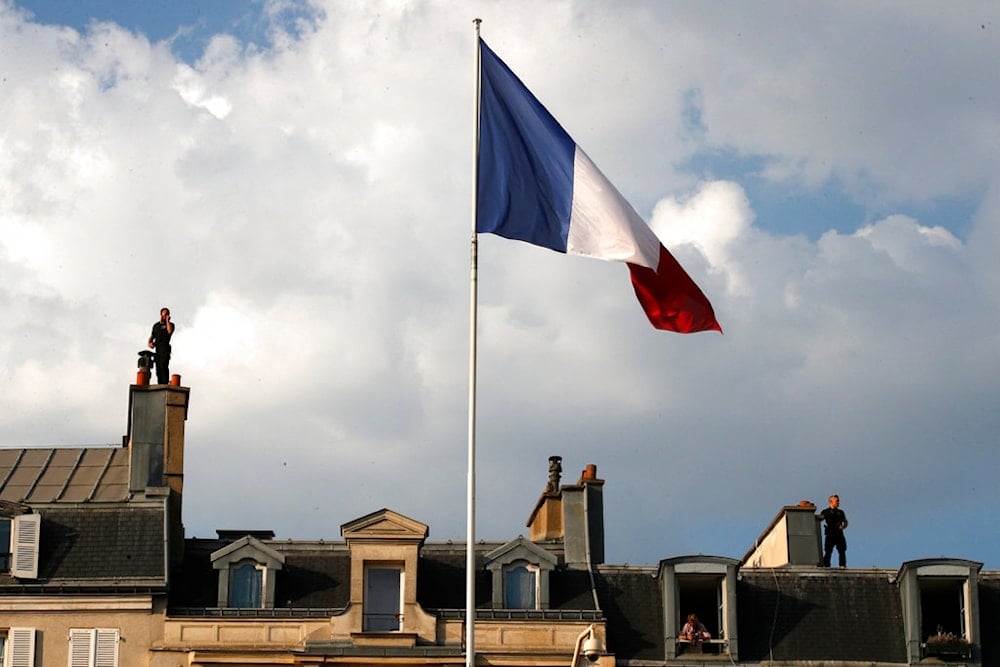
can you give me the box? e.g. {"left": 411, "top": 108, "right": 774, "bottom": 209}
{"left": 486, "top": 536, "right": 557, "bottom": 609}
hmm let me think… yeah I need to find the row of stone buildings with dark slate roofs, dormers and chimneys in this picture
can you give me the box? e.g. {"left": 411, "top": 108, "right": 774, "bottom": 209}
{"left": 0, "top": 374, "right": 1000, "bottom": 667}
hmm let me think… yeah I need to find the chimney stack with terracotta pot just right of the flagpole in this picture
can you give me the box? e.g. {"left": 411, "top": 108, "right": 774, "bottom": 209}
{"left": 527, "top": 464, "right": 604, "bottom": 569}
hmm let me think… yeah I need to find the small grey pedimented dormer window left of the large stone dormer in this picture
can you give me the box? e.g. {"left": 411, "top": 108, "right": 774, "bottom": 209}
{"left": 211, "top": 535, "right": 285, "bottom": 609}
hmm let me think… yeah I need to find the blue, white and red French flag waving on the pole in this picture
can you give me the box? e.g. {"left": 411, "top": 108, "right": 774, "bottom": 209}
{"left": 476, "top": 39, "right": 722, "bottom": 333}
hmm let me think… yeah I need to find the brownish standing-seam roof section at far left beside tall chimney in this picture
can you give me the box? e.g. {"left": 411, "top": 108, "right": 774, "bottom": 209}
{"left": 0, "top": 445, "right": 129, "bottom": 505}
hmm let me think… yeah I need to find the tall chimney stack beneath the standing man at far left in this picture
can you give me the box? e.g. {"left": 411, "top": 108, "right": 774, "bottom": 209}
{"left": 125, "top": 375, "right": 191, "bottom": 576}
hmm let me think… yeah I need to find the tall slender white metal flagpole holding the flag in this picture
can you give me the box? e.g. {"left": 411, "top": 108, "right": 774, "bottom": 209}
{"left": 465, "top": 19, "right": 482, "bottom": 667}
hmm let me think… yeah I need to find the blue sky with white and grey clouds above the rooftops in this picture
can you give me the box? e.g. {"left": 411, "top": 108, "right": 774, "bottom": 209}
{"left": 0, "top": 0, "right": 1000, "bottom": 568}
